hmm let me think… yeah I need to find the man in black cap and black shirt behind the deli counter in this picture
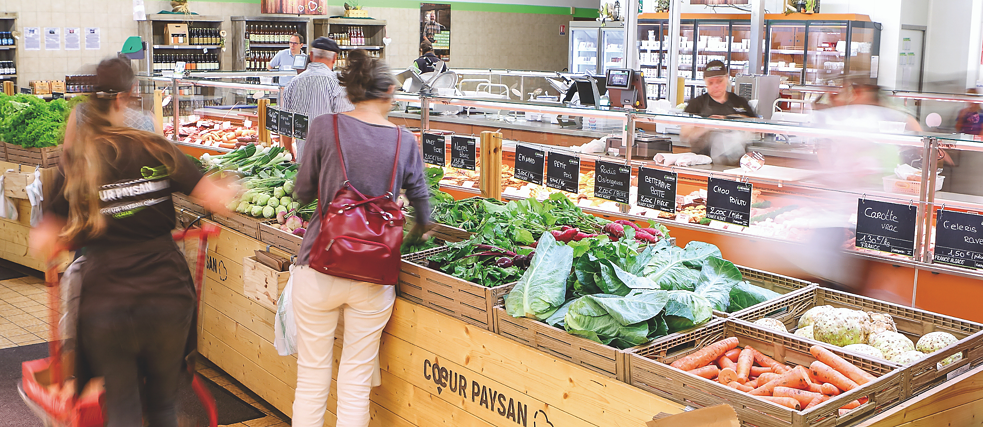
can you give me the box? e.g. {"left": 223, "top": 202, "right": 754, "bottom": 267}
{"left": 680, "top": 61, "right": 757, "bottom": 165}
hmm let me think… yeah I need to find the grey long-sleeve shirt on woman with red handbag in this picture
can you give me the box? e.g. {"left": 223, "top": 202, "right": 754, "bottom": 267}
{"left": 294, "top": 114, "right": 430, "bottom": 265}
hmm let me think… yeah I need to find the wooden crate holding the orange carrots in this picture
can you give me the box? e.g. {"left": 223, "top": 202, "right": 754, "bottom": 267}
{"left": 628, "top": 318, "right": 905, "bottom": 427}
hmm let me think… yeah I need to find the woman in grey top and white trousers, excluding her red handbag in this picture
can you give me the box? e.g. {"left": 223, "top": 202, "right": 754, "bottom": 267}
{"left": 292, "top": 50, "right": 430, "bottom": 427}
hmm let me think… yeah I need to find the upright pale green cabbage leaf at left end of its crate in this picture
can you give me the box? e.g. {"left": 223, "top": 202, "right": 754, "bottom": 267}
{"left": 505, "top": 233, "right": 573, "bottom": 320}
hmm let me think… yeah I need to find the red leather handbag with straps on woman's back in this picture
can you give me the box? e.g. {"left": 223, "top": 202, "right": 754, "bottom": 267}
{"left": 309, "top": 115, "right": 405, "bottom": 285}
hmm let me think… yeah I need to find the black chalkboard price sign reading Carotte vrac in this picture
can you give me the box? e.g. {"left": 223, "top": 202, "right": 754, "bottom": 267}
{"left": 856, "top": 199, "right": 918, "bottom": 256}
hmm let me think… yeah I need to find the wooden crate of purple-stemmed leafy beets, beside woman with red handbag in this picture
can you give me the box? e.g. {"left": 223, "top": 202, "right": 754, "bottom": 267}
{"left": 396, "top": 247, "right": 515, "bottom": 332}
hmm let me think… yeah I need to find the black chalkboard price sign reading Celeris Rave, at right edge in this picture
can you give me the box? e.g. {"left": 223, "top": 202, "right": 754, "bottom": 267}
{"left": 933, "top": 209, "right": 983, "bottom": 268}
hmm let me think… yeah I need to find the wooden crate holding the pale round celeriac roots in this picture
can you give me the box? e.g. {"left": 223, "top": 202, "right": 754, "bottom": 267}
{"left": 734, "top": 287, "right": 983, "bottom": 397}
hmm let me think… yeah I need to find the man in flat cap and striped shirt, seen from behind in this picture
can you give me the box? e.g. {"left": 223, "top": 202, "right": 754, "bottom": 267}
{"left": 280, "top": 37, "right": 355, "bottom": 161}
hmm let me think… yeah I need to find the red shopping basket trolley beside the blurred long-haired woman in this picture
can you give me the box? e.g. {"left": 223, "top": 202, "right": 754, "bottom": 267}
{"left": 20, "top": 224, "right": 221, "bottom": 427}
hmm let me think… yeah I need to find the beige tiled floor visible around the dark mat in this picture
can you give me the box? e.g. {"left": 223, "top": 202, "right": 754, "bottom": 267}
{"left": 0, "top": 276, "right": 290, "bottom": 427}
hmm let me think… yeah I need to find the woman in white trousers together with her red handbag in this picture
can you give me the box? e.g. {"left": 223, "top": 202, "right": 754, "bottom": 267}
{"left": 292, "top": 50, "right": 430, "bottom": 427}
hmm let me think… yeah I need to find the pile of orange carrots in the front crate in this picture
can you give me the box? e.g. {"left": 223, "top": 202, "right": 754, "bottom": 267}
{"left": 671, "top": 337, "right": 876, "bottom": 414}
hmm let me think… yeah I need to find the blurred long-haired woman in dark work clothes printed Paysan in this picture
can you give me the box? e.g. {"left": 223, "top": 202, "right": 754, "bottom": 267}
{"left": 30, "top": 59, "right": 234, "bottom": 427}
